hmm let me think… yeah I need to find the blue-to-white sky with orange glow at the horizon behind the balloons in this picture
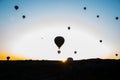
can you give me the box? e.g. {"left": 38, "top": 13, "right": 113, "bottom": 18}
{"left": 0, "top": 0, "right": 120, "bottom": 60}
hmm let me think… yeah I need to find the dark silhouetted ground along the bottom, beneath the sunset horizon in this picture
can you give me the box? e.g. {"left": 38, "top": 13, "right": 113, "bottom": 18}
{"left": 0, "top": 59, "right": 120, "bottom": 80}
